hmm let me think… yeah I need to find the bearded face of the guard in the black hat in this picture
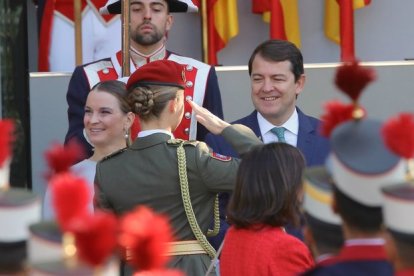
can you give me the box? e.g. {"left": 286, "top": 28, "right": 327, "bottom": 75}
{"left": 130, "top": 0, "right": 172, "bottom": 46}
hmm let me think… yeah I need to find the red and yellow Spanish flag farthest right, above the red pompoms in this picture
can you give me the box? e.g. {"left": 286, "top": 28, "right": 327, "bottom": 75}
{"left": 325, "top": 0, "right": 371, "bottom": 61}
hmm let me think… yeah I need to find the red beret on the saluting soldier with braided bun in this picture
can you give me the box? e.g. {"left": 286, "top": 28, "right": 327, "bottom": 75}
{"left": 126, "top": 59, "right": 185, "bottom": 90}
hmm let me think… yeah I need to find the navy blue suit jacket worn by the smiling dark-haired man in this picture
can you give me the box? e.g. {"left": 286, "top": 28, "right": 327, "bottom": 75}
{"left": 205, "top": 107, "right": 330, "bottom": 248}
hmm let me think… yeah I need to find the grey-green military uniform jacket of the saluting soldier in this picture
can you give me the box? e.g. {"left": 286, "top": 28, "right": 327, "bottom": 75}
{"left": 95, "top": 125, "right": 262, "bottom": 275}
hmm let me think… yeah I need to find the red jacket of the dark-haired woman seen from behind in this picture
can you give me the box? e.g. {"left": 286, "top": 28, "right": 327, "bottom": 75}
{"left": 220, "top": 227, "right": 314, "bottom": 276}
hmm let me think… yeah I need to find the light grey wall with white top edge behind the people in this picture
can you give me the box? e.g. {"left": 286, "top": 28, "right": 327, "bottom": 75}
{"left": 30, "top": 62, "right": 414, "bottom": 197}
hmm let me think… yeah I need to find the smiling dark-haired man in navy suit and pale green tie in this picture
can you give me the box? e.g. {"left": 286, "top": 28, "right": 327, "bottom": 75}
{"left": 205, "top": 40, "right": 329, "bottom": 247}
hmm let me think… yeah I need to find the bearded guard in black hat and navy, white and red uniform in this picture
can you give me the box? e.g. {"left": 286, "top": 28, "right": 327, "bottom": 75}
{"left": 65, "top": 0, "right": 223, "bottom": 156}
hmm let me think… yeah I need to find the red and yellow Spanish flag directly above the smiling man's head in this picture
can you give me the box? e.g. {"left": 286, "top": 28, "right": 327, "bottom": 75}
{"left": 252, "top": 0, "right": 301, "bottom": 47}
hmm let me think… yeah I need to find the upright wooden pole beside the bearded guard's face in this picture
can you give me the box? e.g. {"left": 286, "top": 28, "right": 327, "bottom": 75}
{"left": 121, "top": 0, "right": 131, "bottom": 77}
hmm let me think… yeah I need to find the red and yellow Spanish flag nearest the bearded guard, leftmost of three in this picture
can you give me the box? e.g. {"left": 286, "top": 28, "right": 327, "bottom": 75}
{"left": 193, "top": 0, "right": 239, "bottom": 65}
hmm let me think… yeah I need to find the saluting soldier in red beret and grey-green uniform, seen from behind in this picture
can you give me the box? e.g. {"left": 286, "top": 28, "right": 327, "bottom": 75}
{"left": 95, "top": 60, "right": 262, "bottom": 276}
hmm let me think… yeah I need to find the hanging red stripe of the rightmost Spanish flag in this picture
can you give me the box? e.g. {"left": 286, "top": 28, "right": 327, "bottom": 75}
{"left": 338, "top": 0, "right": 355, "bottom": 61}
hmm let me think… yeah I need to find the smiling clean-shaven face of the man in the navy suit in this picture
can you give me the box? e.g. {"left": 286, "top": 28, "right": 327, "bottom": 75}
{"left": 250, "top": 54, "right": 305, "bottom": 125}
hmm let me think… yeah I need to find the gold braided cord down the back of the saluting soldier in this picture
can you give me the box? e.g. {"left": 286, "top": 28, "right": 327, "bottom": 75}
{"left": 177, "top": 143, "right": 220, "bottom": 258}
